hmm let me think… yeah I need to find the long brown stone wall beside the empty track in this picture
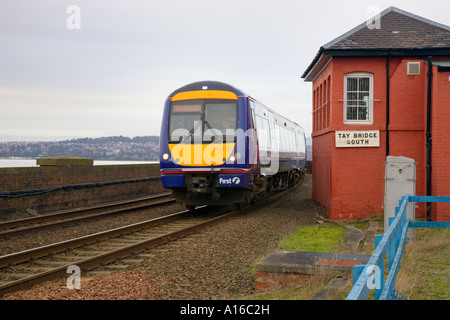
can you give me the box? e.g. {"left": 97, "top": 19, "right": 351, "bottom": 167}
{"left": 0, "top": 159, "right": 164, "bottom": 218}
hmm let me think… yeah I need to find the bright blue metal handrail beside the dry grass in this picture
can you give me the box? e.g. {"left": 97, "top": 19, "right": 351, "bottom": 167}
{"left": 347, "top": 195, "right": 450, "bottom": 300}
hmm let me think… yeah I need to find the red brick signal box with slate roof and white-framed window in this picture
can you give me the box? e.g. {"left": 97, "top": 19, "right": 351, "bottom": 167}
{"left": 302, "top": 7, "right": 450, "bottom": 221}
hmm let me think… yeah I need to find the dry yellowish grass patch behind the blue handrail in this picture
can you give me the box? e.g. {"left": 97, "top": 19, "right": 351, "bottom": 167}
{"left": 396, "top": 228, "right": 450, "bottom": 300}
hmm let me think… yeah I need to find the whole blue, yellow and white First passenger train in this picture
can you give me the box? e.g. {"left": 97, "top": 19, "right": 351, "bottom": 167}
{"left": 160, "top": 81, "right": 306, "bottom": 209}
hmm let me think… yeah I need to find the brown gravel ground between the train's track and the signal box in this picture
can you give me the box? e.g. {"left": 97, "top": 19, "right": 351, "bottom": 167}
{"left": 3, "top": 175, "right": 321, "bottom": 300}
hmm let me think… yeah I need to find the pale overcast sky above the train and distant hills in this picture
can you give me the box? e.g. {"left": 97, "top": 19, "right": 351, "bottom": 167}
{"left": 0, "top": 0, "right": 450, "bottom": 141}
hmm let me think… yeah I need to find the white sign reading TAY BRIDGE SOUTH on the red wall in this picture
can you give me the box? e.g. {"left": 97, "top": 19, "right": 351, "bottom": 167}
{"left": 335, "top": 130, "right": 380, "bottom": 148}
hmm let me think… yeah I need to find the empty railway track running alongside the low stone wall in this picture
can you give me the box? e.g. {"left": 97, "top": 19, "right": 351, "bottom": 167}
{"left": 0, "top": 193, "right": 175, "bottom": 237}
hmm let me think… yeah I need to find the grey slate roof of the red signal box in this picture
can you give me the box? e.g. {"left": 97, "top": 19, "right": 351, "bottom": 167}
{"left": 302, "top": 7, "right": 450, "bottom": 81}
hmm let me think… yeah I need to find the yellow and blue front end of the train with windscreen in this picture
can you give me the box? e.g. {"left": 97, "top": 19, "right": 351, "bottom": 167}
{"left": 160, "top": 81, "right": 253, "bottom": 208}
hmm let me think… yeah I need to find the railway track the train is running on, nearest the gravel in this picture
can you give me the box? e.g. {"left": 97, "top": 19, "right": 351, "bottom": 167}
{"left": 0, "top": 183, "right": 301, "bottom": 297}
